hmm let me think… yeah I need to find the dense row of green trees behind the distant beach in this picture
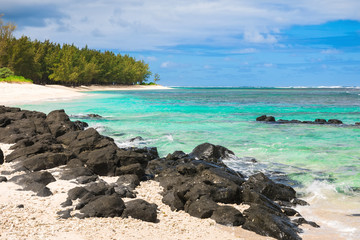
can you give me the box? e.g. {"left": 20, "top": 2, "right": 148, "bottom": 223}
{"left": 0, "top": 15, "right": 159, "bottom": 86}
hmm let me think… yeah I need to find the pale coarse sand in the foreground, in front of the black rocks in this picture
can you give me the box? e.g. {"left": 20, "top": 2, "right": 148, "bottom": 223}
{"left": 0, "top": 144, "right": 273, "bottom": 240}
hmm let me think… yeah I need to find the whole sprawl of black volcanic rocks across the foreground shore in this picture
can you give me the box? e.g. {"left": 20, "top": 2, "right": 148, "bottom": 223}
{"left": 0, "top": 106, "right": 317, "bottom": 239}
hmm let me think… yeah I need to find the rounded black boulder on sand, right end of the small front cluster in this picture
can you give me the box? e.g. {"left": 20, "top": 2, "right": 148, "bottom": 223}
{"left": 122, "top": 199, "right": 157, "bottom": 222}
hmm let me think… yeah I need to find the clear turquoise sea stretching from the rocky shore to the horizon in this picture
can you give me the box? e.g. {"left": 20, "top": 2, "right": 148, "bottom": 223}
{"left": 20, "top": 88, "right": 360, "bottom": 239}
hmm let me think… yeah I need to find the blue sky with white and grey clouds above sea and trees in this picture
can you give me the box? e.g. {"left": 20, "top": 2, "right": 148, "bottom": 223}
{"left": 0, "top": 0, "right": 360, "bottom": 87}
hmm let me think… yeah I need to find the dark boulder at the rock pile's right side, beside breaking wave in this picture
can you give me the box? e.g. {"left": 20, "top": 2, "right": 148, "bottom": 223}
{"left": 242, "top": 173, "right": 296, "bottom": 202}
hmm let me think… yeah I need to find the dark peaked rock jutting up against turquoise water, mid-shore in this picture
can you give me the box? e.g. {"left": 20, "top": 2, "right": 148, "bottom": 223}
{"left": 190, "top": 143, "right": 234, "bottom": 166}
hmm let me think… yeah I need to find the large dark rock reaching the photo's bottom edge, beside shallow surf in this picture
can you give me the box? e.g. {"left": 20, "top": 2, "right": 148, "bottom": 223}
{"left": 242, "top": 204, "right": 301, "bottom": 240}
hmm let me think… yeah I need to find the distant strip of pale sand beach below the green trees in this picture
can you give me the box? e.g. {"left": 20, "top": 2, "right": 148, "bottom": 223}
{"left": 0, "top": 83, "right": 169, "bottom": 106}
